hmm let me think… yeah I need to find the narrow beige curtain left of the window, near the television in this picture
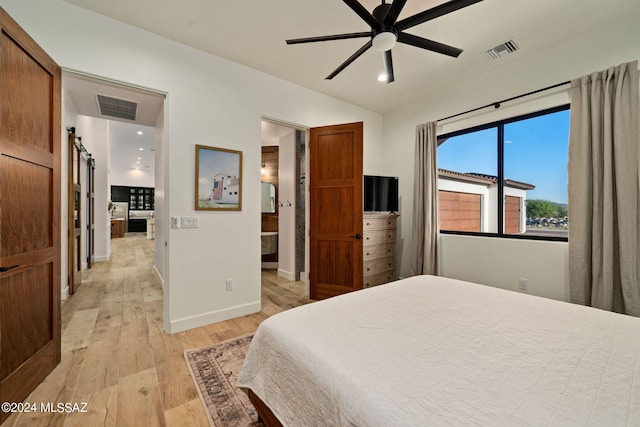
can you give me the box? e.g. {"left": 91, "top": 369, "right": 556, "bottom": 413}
{"left": 411, "top": 122, "right": 438, "bottom": 275}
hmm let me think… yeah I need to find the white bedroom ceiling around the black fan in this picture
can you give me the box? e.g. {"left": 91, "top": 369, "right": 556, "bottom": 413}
{"left": 66, "top": 0, "right": 640, "bottom": 113}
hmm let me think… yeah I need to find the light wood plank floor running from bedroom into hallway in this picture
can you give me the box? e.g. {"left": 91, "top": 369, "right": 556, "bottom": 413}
{"left": 3, "top": 233, "right": 309, "bottom": 427}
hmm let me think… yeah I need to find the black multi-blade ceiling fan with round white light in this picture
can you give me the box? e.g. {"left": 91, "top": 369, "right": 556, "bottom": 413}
{"left": 286, "top": 0, "right": 482, "bottom": 83}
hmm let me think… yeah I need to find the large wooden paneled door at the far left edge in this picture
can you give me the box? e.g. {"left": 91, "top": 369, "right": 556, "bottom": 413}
{"left": 0, "top": 8, "right": 61, "bottom": 422}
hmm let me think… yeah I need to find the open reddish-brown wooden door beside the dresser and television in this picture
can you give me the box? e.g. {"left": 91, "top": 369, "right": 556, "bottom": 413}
{"left": 309, "top": 123, "right": 363, "bottom": 299}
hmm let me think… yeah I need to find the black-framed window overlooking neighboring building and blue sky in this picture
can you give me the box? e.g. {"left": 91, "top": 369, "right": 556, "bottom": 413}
{"left": 438, "top": 105, "right": 569, "bottom": 240}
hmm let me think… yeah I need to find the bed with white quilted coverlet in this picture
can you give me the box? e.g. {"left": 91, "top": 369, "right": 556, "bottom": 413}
{"left": 237, "top": 276, "right": 640, "bottom": 426}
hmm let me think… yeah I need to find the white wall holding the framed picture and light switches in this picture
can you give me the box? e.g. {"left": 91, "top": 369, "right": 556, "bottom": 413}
{"left": 0, "top": 0, "right": 383, "bottom": 332}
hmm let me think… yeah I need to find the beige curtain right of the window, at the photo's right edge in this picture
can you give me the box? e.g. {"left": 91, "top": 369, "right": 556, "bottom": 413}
{"left": 569, "top": 61, "right": 640, "bottom": 316}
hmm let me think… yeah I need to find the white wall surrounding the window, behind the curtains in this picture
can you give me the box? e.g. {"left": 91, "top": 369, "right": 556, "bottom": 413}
{"left": 384, "top": 11, "right": 640, "bottom": 299}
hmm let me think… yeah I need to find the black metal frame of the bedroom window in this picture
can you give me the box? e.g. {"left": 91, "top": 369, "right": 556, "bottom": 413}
{"left": 436, "top": 104, "right": 571, "bottom": 242}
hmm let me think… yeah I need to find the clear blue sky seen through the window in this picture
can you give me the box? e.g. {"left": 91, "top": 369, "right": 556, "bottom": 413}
{"left": 438, "top": 110, "right": 569, "bottom": 203}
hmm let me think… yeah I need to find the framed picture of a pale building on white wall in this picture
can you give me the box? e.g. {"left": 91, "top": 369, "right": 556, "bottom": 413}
{"left": 195, "top": 145, "right": 242, "bottom": 211}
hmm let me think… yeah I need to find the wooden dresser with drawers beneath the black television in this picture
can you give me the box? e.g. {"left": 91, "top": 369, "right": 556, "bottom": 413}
{"left": 362, "top": 212, "right": 398, "bottom": 288}
